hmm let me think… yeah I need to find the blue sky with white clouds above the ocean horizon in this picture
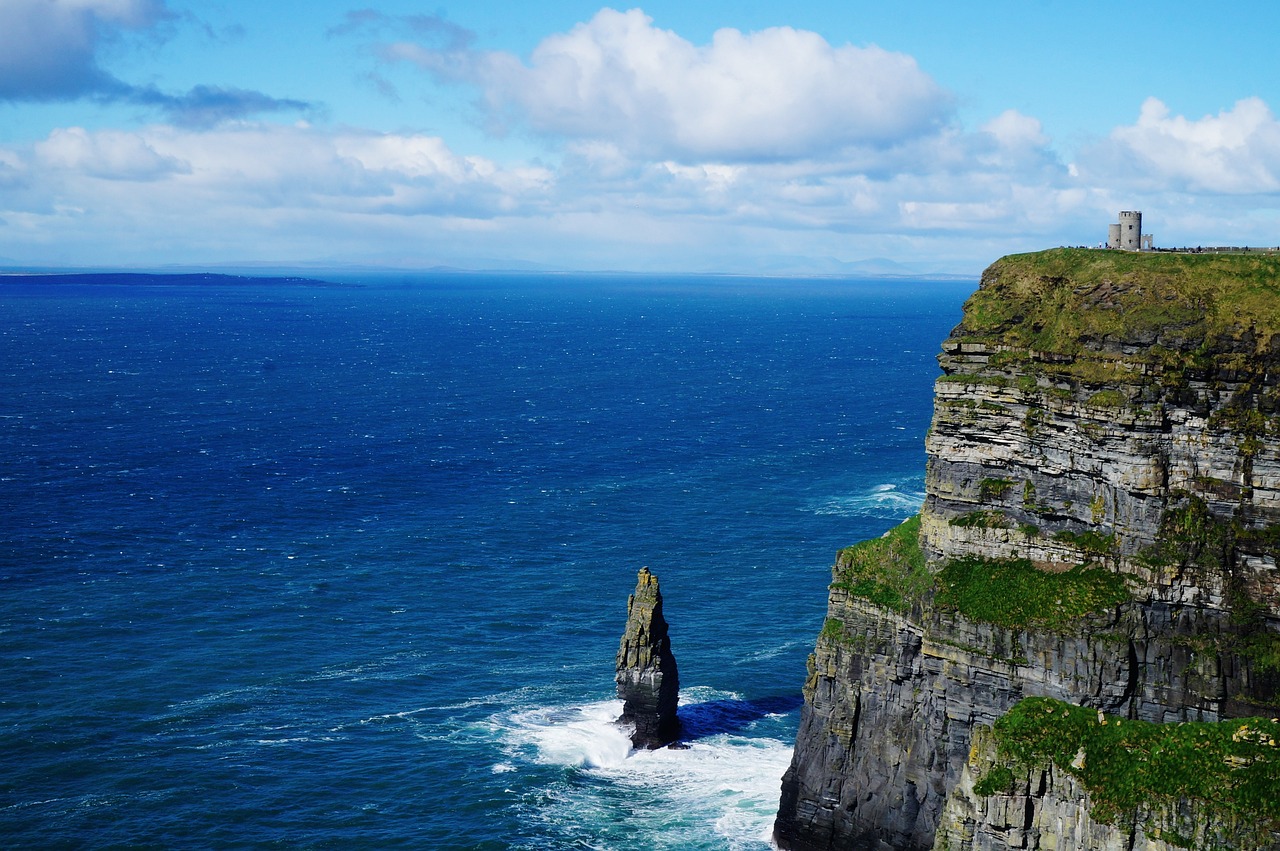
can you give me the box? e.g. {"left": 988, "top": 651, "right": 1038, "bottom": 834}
{"left": 0, "top": 0, "right": 1280, "bottom": 274}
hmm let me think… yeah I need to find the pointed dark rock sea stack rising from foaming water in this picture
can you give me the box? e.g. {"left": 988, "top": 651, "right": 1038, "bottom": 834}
{"left": 614, "top": 567, "right": 680, "bottom": 750}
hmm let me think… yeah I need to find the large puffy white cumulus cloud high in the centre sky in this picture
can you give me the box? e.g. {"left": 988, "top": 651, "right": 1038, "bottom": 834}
{"left": 379, "top": 9, "right": 951, "bottom": 161}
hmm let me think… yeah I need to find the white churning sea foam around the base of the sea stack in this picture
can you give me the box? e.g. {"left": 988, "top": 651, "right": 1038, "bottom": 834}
{"left": 493, "top": 688, "right": 791, "bottom": 851}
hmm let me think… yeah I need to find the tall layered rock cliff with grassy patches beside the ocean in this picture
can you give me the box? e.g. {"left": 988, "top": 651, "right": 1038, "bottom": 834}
{"left": 774, "top": 250, "right": 1280, "bottom": 851}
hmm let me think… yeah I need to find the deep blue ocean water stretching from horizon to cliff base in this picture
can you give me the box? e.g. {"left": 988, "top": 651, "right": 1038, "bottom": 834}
{"left": 0, "top": 275, "right": 972, "bottom": 850}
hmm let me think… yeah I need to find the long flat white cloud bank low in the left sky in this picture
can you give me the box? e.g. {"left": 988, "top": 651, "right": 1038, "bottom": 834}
{"left": 0, "top": 124, "right": 550, "bottom": 220}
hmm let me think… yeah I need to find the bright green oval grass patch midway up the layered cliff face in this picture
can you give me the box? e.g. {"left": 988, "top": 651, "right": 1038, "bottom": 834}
{"left": 934, "top": 555, "right": 1129, "bottom": 630}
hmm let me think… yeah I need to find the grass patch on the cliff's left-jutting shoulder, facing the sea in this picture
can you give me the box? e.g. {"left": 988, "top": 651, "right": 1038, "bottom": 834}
{"left": 833, "top": 517, "right": 933, "bottom": 612}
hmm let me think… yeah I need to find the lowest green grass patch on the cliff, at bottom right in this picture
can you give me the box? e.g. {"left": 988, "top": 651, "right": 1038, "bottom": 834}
{"left": 984, "top": 697, "right": 1280, "bottom": 847}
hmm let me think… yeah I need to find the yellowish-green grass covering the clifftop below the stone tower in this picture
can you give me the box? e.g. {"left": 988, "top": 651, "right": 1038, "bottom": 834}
{"left": 959, "top": 248, "right": 1280, "bottom": 354}
